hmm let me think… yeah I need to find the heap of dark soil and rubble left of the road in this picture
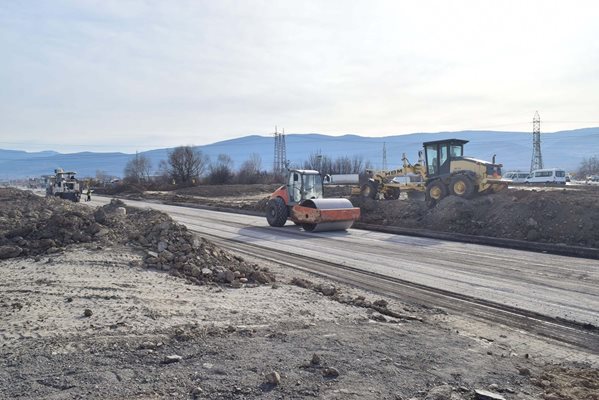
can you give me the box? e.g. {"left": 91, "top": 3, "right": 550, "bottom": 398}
{"left": 0, "top": 189, "right": 274, "bottom": 287}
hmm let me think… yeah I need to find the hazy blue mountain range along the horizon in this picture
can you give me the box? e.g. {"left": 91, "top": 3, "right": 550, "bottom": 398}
{"left": 0, "top": 128, "right": 599, "bottom": 180}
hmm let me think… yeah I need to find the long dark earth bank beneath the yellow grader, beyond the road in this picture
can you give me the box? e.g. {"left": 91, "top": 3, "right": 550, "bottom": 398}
{"left": 351, "top": 189, "right": 599, "bottom": 247}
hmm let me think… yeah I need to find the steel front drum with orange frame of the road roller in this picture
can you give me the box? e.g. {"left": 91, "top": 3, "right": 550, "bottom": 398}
{"left": 291, "top": 199, "right": 360, "bottom": 232}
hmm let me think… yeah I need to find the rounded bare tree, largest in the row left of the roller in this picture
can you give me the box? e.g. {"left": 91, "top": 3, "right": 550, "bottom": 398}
{"left": 167, "top": 146, "right": 210, "bottom": 185}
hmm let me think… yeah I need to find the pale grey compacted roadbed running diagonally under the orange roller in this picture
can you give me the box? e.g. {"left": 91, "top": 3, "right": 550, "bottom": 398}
{"left": 86, "top": 198, "right": 599, "bottom": 330}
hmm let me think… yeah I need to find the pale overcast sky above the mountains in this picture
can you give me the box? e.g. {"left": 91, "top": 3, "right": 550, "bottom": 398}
{"left": 0, "top": 0, "right": 599, "bottom": 152}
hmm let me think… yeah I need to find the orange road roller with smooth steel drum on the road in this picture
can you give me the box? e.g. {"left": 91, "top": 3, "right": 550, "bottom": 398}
{"left": 266, "top": 169, "right": 360, "bottom": 232}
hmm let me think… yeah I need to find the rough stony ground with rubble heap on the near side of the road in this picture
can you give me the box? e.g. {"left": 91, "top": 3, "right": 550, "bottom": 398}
{"left": 0, "top": 188, "right": 599, "bottom": 400}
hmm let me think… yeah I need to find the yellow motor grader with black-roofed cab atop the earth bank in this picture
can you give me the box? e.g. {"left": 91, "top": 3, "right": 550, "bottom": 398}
{"left": 360, "top": 139, "right": 507, "bottom": 206}
